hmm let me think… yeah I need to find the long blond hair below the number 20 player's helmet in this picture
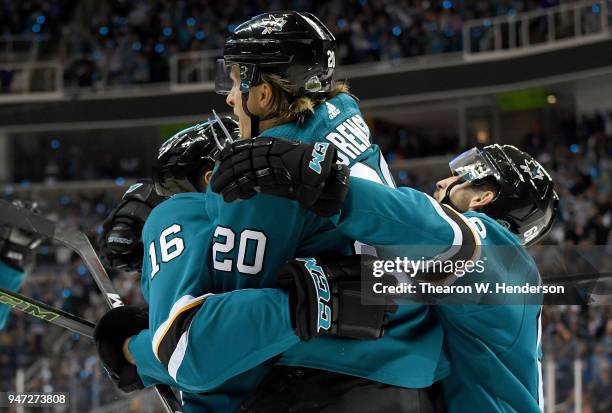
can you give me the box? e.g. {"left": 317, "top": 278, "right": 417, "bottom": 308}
{"left": 261, "top": 73, "right": 358, "bottom": 123}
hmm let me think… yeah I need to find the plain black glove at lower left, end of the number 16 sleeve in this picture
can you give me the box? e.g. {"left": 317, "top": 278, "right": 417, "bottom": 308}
{"left": 94, "top": 305, "right": 149, "bottom": 393}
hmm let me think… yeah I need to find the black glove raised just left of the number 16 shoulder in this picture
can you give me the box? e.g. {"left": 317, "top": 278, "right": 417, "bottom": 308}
{"left": 100, "top": 180, "right": 166, "bottom": 271}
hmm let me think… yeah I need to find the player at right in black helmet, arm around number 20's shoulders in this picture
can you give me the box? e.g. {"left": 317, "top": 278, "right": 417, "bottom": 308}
{"left": 211, "top": 139, "right": 558, "bottom": 413}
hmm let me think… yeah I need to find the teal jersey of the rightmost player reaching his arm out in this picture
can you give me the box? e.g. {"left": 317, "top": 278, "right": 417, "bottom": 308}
{"left": 330, "top": 179, "right": 543, "bottom": 413}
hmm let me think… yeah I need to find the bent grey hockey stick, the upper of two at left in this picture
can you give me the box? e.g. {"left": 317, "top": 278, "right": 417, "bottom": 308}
{"left": 0, "top": 200, "right": 183, "bottom": 413}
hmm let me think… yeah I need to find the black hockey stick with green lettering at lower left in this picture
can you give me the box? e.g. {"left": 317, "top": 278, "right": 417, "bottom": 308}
{"left": 0, "top": 287, "right": 95, "bottom": 339}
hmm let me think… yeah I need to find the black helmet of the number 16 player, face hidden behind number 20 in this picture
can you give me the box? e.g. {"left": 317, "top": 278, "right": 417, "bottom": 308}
{"left": 154, "top": 111, "right": 238, "bottom": 196}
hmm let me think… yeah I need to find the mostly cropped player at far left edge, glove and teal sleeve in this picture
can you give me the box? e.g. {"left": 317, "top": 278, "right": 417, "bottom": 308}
{"left": 0, "top": 201, "right": 42, "bottom": 330}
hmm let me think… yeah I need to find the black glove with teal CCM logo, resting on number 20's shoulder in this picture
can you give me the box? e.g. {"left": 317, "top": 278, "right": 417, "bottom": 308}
{"left": 211, "top": 138, "right": 349, "bottom": 216}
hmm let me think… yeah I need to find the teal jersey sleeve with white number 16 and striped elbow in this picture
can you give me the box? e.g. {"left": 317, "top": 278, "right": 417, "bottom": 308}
{"left": 130, "top": 193, "right": 299, "bottom": 392}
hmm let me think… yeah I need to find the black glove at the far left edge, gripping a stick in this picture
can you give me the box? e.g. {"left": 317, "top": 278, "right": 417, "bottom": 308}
{"left": 0, "top": 201, "right": 43, "bottom": 271}
